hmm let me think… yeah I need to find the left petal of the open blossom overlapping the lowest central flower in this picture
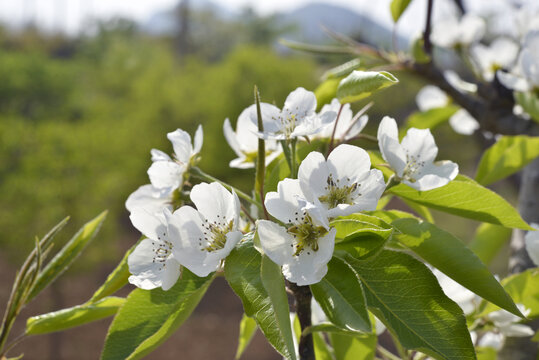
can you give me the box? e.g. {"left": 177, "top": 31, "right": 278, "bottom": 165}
{"left": 298, "top": 151, "right": 329, "bottom": 198}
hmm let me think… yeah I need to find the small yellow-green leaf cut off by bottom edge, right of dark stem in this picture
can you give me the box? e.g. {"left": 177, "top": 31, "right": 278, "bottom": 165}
{"left": 329, "top": 333, "right": 377, "bottom": 360}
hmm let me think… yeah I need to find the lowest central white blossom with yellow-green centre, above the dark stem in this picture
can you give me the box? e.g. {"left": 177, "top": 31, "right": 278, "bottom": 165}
{"left": 257, "top": 179, "right": 337, "bottom": 286}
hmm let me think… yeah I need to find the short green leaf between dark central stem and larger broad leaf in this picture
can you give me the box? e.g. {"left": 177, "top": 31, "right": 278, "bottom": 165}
{"left": 311, "top": 258, "right": 371, "bottom": 332}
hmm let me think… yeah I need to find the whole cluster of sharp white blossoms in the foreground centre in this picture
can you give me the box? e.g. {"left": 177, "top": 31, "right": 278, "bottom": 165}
{"left": 126, "top": 88, "right": 458, "bottom": 290}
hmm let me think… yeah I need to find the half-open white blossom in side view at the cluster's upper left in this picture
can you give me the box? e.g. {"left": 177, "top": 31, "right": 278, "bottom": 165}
{"left": 148, "top": 125, "right": 203, "bottom": 194}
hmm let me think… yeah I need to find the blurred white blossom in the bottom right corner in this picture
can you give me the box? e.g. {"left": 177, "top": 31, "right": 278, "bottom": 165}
{"left": 478, "top": 304, "right": 535, "bottom": 350}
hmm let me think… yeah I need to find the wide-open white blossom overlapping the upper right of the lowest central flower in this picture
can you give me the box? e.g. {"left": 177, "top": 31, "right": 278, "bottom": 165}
{"left": 298, "top": 144, "right": 385, "bottom": 217}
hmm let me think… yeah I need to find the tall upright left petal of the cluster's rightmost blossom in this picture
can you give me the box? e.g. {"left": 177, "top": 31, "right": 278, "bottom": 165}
{"left": 377, "top": 116, "right": 406, "bottom": 176}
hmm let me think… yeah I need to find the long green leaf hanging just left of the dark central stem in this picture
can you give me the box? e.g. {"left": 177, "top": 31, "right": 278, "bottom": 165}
{"left": 225, "top": 242, "right": 296, "bottom": 359}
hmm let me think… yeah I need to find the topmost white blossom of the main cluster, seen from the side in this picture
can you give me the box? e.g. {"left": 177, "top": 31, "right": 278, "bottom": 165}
{"left": 252, "top": 87, "right": 337, "bottom": 140}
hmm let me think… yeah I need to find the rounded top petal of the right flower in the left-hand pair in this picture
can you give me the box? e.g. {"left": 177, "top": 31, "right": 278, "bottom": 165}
{"left": 191, "top": 182, "right": 239, "bottom": 226}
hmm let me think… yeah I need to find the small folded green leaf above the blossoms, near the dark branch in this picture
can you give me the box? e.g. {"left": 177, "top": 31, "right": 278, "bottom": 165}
{"left": 337, "top": 70, "right": 399, "bottom": 104}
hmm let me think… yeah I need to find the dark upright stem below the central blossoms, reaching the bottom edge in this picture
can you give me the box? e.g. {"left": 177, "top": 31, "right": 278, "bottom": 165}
{"left": 288, "top": 283, "right": 315, "bottom": 360}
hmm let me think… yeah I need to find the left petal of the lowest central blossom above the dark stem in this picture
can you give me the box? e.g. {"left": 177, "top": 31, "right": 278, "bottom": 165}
{"left": 256, "top": 220, "right": 295, "bottom": 266}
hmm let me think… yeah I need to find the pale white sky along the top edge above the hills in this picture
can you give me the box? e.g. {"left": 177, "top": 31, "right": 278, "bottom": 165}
{"left": 0, "top": 0, "right": 508, "bottom": 34}
